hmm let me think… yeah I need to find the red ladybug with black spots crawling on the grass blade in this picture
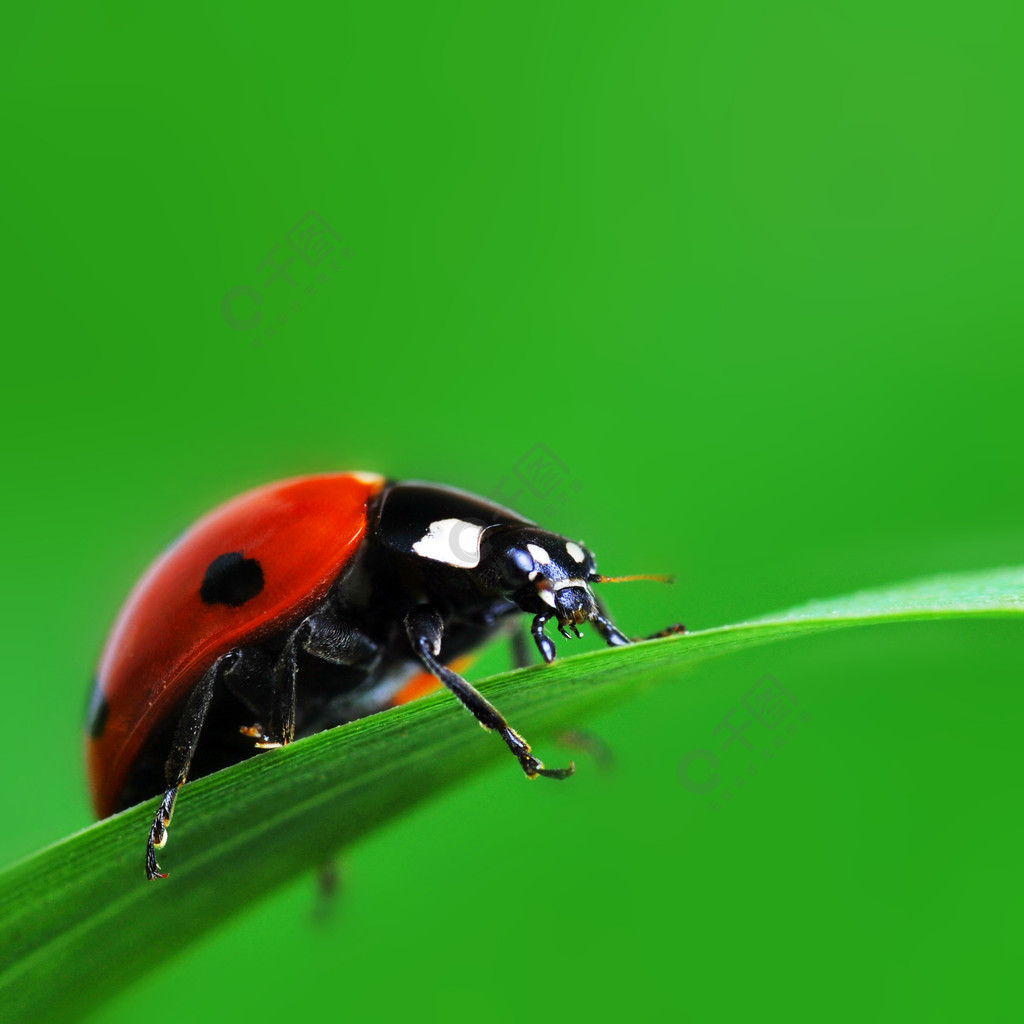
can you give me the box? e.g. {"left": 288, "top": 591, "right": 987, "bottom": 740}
{"left": 86, "top": 473, "right": 683, "bottom": 880}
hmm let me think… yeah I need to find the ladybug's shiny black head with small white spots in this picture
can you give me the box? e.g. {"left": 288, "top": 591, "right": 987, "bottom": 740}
{"left": 478, "top": 523, "right": 600, "bottom": 635}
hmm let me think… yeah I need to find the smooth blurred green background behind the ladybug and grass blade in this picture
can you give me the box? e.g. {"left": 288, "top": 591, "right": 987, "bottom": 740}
{"left": 0, "top": 0, "right": 1024, "bottom": 1022}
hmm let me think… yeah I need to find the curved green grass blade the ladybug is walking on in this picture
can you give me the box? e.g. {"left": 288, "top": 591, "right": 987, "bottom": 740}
{"left": 0, "top": 567, "right": 1024, "bottom": 1022}
